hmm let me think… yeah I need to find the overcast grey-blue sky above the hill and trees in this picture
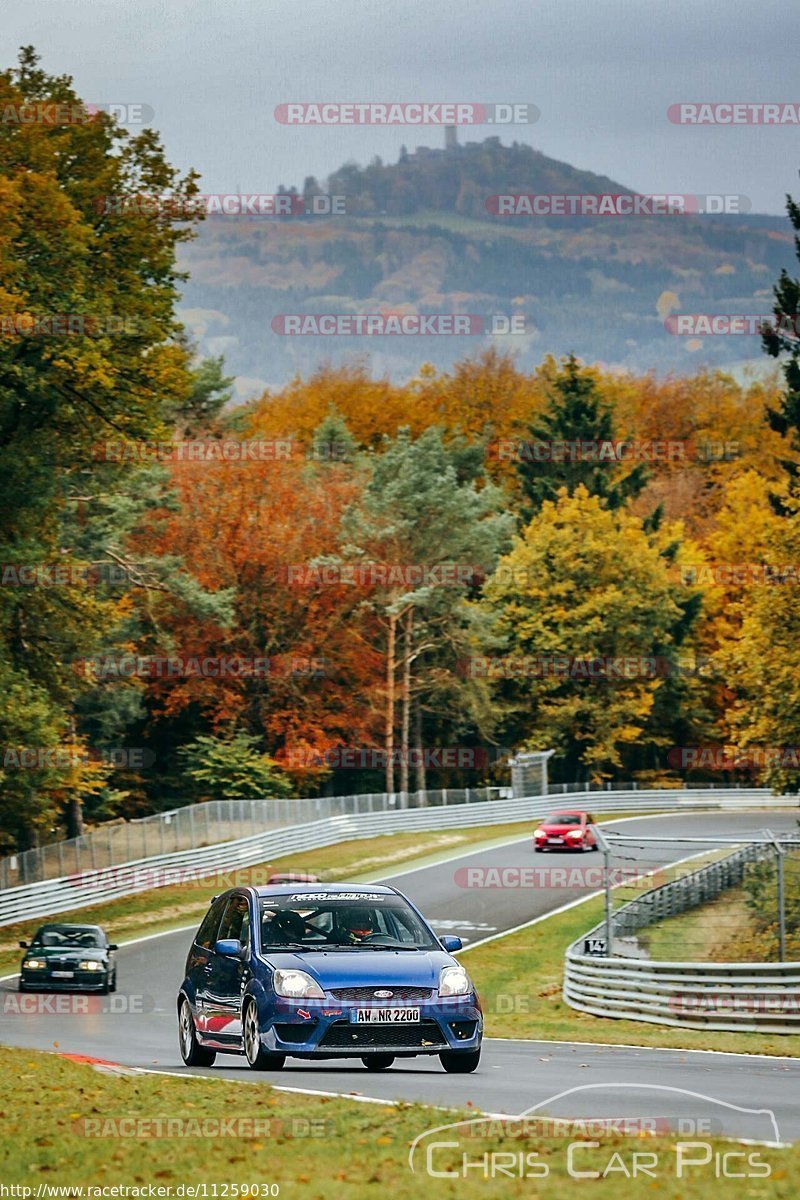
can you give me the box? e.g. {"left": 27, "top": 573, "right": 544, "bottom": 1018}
{"left": 0, "top": 0, "right": 800, "bottom": 212}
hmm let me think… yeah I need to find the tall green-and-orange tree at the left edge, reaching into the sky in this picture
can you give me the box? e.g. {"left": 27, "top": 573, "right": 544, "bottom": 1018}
{"left": 0, "top": 48, "right": 197, "bottom": 846}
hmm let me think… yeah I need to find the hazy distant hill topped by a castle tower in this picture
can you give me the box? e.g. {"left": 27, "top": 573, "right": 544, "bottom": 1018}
{"left": 176, "top": 137, "right": 794, "bottom": 392}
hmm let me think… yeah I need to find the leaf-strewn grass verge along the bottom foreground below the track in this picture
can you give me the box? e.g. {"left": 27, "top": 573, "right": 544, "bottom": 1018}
{"left": 0, "top": 1049, "right": 800, "bottom": 1200}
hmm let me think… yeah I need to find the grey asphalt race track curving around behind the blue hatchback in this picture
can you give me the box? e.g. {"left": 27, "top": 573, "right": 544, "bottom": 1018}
{"left": 0, "top": 810, "right": 800, "bottom": 1141}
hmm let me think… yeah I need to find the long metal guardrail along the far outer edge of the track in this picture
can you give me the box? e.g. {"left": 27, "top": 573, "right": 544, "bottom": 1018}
{"left": 0, "top": 788, "right": 798, "bottom": 926}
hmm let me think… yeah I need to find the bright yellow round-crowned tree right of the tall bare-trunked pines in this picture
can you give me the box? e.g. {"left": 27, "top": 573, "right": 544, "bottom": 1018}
{"left": 485, "top": 484, "right": 692, "bottom": 780}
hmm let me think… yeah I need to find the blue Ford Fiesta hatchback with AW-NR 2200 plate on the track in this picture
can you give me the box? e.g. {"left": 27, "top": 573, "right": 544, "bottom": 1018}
{"left": 178, "top": 883, "right": 483, "bottom": 1073}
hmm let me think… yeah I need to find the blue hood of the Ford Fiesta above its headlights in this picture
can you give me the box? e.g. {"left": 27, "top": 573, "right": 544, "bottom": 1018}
{"left": 263, "top": 950, "right": 457, "bottom": 990}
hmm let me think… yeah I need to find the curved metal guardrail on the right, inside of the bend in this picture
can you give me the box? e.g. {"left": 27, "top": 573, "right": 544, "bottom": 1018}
{"left": 564, "top": 841, "right": 800, "bottom": 1033}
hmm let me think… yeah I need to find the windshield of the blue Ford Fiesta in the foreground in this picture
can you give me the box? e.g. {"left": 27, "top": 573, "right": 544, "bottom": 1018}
{"left": 261, "top": 893, "right": 440, "bottom": 950}
